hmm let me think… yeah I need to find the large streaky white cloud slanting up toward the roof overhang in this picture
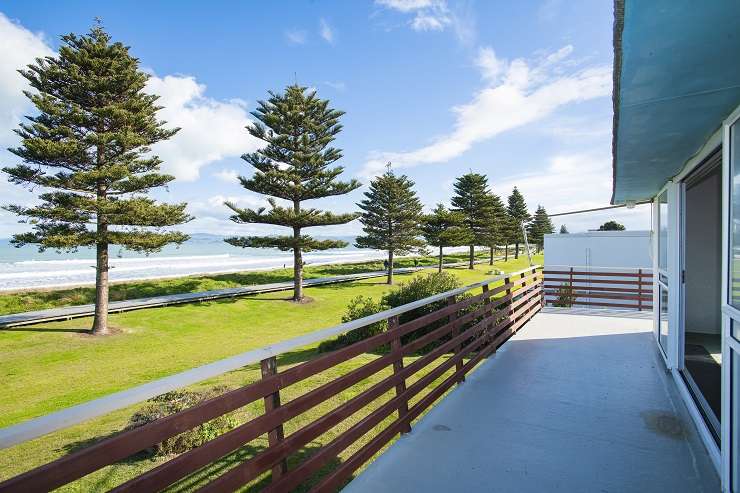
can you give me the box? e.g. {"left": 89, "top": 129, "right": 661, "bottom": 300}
{"left": 361, "top": 47, "right": 612, "bottom": 177}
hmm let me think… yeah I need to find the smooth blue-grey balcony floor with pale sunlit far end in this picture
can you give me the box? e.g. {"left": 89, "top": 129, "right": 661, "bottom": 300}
{"left": 344, "top": 309, "right": 720, "bottom": 493}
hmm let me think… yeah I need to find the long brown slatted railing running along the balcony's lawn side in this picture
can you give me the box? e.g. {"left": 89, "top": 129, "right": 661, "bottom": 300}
{"left": 0, "top": 267, "right": 543, "bottom": 492}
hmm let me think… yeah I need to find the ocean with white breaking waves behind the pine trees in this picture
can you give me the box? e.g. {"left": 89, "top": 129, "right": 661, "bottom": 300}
{"left": 0, "top": 234, "right": 394, "bottom": 291}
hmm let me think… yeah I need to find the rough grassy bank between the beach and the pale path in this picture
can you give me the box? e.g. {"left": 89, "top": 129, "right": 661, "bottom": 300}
{"left": 0, "top": 252, "right": 498, "bottom": 315}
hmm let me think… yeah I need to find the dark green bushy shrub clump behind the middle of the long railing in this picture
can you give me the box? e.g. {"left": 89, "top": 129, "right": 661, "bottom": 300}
{"left": 319, "top": 272, "right": 460, "bottom": 352}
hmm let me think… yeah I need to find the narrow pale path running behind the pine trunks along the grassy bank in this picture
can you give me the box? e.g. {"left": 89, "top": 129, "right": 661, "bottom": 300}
{"left": 0, "top": 260, "right": 494, "bottom": 329}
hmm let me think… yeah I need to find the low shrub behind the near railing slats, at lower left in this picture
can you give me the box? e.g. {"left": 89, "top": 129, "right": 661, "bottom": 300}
{"left": 127, "top": 386, "right": 237, "bottom": 455}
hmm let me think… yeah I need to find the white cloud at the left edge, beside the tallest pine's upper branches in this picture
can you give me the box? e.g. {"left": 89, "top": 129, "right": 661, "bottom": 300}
{"left": 0, "top": 13, "right": 53, "bottom": 147}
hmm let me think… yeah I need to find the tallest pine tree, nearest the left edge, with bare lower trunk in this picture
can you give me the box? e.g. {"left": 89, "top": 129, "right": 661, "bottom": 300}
{"left": 3, "top": 25, "right": 190, "bottom": 334}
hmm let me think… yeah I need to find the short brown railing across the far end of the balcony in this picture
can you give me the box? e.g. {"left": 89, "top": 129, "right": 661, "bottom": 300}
{"left": 544, "top": 266, "right": 653, "bottom": 311}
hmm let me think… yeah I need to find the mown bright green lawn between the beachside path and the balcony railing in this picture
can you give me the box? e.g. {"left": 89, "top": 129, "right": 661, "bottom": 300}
{"left": 0, "top": 257, "right": 542, "bottom": 491}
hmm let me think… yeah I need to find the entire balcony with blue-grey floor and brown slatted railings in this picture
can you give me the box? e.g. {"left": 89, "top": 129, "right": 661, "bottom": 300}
{"left": 0, "top": 268, "right": 719, "bottom": 492}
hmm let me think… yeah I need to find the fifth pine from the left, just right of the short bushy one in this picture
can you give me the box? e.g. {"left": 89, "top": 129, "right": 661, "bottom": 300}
{"left": 452, "top": 171, "right": 493, "bottom": 269}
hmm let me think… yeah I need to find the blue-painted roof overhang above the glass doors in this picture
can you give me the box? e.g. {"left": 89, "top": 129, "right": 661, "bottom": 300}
{"left": 612, "top": 0, "right": 740, "bottom": 204}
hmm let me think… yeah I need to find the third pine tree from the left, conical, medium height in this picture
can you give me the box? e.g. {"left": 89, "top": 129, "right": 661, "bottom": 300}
{"left": 356, "top": 163, "right": 424, "bottom": 284}
